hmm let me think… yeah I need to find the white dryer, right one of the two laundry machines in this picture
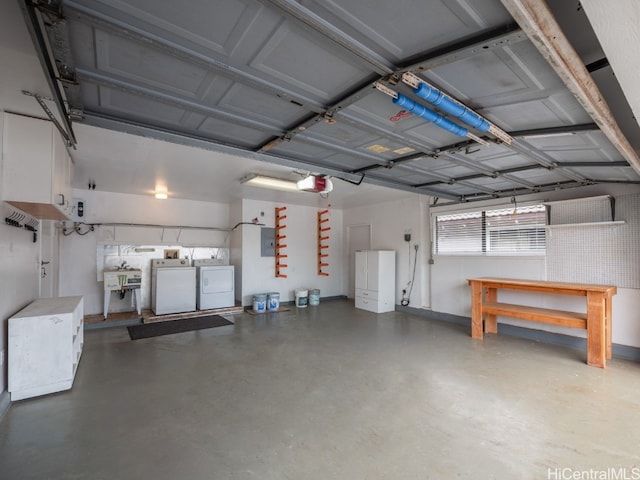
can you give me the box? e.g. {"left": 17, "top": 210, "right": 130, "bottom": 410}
{"left": 193, "top": 258, "right": 236, "bottom": 310}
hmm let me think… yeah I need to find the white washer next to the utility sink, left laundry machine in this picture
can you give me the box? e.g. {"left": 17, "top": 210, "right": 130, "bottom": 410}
{"left": 151, "top": 259, "right": 196, "bottom": 315}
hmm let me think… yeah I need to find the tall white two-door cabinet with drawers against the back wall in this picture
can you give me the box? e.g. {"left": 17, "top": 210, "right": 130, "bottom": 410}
{"left": 355, "top": 250, "right": 396, "bottom": 313}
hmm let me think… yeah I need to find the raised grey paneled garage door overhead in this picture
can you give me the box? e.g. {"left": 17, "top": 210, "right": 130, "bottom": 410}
{"left": 22, "top": 0, "right": 640, "bottom": 201}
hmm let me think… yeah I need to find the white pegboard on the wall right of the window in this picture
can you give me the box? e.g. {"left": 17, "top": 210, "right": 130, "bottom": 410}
{"left": 547, "top": 195, "right": 640, "bottom": 289}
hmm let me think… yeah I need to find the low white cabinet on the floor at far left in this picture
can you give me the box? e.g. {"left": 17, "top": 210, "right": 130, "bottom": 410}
{"left": 8, "top": 297, "right": 84, "bottom": 400}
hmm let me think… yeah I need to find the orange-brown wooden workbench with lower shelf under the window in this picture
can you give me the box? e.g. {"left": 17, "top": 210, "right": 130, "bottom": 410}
{"left": 467, "top": 277, "right": 617, "bottom": 368}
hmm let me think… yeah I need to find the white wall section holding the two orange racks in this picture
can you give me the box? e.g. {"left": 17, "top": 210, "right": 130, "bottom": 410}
{"left": 241, "top": 200, "right": 346, "bottom": 306}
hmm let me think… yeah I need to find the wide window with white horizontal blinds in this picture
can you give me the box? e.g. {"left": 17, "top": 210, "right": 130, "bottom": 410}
{"left": 435, "top": 205, "right": 546, "bottom": 255}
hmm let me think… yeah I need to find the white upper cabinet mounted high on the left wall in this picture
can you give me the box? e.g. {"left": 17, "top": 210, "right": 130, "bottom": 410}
{"left": 2, "top": 113, "right": 72, "bottom": 220}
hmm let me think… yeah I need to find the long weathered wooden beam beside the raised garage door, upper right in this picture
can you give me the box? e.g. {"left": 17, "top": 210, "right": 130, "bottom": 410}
{"left": 501, "top": 0, "right": 640, "bottom": 173}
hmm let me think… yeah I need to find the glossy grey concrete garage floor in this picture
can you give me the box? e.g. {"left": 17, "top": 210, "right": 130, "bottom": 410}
{"left": 0, "top": 300, "right": 640, "bottom": 480}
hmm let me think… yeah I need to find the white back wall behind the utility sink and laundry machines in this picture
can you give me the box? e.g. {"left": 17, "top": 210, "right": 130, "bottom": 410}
{"left": 60, "top": 190, "right": 233, "bottom": 315}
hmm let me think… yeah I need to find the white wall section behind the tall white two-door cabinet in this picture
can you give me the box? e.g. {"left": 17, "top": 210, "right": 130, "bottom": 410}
{"left": 343, "top": 195, "right": 429, "bottom": 308}
